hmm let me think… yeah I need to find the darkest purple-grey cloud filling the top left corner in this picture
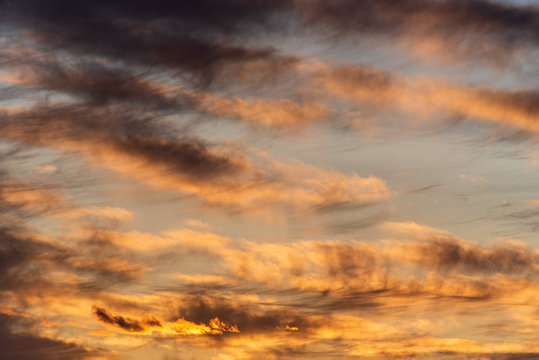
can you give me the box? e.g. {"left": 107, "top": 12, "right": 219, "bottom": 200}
{"left": 0, "top": 0, "right": 298, "bottom": 84}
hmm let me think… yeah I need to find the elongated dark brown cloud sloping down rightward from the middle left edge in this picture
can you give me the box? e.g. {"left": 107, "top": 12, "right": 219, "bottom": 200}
{"left": 0, "top": 105, "right": 245, "bottom": 180}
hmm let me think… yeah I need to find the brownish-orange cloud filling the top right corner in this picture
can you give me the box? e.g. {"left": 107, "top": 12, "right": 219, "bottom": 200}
{"left": 297, "top": 0, "right": 539, "bottom": 64}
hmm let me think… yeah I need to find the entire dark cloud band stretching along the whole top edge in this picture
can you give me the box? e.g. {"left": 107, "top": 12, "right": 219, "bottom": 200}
{"left": 3, "top": 0, "right": 539, "bottom": 71}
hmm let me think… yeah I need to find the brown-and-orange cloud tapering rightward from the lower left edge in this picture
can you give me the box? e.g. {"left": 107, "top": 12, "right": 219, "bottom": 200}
{"left": 0, "top": 224, "right": 148, "bottom": 299}
